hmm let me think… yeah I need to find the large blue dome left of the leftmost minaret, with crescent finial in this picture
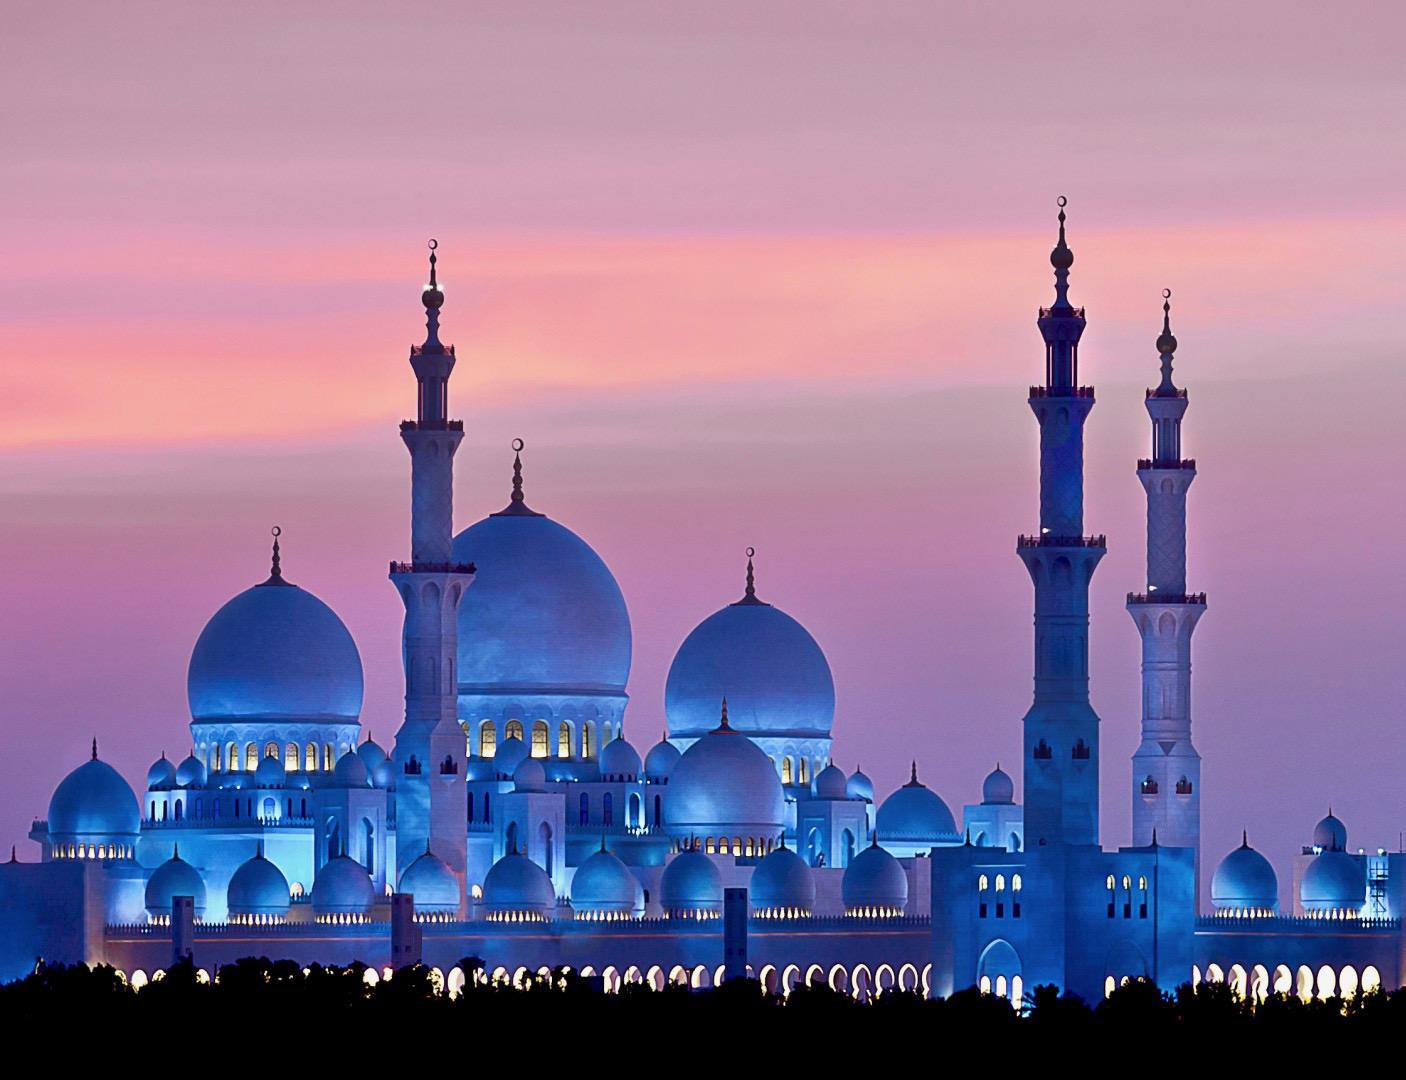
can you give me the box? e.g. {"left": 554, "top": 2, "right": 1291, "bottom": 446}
{"left": 186, "top": 551, "right": 361, "bottom": 723}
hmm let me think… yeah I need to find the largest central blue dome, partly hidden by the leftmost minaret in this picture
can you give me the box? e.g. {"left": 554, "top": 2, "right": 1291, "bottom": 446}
{"left": 453, "top": 489, "right": 630, "bottom": 695}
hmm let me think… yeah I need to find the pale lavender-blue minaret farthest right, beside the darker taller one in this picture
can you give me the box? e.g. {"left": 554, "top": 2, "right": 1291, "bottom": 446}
{"left": 1128, "top": 290, "right": 1206, "bottom": 904}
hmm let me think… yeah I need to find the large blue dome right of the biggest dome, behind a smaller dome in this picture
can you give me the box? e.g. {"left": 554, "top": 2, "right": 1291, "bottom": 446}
{"left": 664, "top": 564, "right": 835, "bottom": 738}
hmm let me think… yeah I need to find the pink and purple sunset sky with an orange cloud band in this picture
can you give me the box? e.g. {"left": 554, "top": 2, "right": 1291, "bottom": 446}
{"left": 0, "top": 0, "right": 1406, "bottom": 900}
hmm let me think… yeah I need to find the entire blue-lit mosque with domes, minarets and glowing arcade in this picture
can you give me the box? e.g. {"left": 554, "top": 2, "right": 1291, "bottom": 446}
{"left": 0, "top": 210, "right": 1406, "bottom": 1001}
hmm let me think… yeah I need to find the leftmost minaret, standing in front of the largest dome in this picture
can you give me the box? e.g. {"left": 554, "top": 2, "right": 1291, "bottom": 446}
{"left": 391, "top": 240, "right": 474, "bottom": 903}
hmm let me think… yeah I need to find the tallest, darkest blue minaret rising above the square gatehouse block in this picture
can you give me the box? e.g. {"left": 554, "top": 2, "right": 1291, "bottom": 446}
{"left": 1017, "top": 195, "right": 1107, "bottom": 847}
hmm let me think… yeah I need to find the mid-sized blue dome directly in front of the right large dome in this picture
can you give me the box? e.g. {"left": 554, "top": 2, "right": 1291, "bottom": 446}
{"left": 664, "top": 706, "right": 786, "bottom": 840}
